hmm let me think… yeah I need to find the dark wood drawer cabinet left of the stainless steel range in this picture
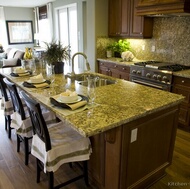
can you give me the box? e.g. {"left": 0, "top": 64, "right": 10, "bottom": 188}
{"left": 98, "top": 61, "right": 130, "bottom": 80}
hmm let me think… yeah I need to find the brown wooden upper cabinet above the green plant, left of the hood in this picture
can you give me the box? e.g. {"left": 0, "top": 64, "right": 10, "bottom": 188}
{"left": 109, "top": 0, "right": 153, "bottom": 38}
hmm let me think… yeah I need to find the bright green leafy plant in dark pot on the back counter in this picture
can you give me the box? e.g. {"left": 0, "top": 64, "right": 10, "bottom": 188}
{"left": 112, "top": 39, "right": 132, "bottom": 57}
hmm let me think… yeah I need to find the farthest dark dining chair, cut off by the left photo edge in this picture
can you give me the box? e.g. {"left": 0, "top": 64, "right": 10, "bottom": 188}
{"left": 0, "top": 75, "right": 14, "bottom": 139}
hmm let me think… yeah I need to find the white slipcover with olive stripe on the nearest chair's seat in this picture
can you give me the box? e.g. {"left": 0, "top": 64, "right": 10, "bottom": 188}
{"left": 31, "top": 122, "right": 91, "bottom": 172}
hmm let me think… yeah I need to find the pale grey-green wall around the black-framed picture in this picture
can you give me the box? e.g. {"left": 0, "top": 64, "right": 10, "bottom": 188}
{"left": 4, "top": 7, "right": 35, "bottom": 50}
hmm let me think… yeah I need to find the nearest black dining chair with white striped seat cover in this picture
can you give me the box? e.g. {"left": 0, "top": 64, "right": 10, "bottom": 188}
{"left": 21, "top": 91, "right": 91, "bottom": 189}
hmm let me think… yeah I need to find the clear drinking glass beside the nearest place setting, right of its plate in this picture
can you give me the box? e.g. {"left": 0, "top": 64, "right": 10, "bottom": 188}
{"left": 87, "top": 76, "right": 98, "bottom": 105}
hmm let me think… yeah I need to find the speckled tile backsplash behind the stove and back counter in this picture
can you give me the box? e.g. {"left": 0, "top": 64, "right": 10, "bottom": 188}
{"left": 97, "top": 17, "right": 190, "bottom": 65}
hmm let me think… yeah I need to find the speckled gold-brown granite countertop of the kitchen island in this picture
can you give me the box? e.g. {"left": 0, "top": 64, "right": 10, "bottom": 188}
{"left": 0, "top": 69, "right": 184, "bottom": 136}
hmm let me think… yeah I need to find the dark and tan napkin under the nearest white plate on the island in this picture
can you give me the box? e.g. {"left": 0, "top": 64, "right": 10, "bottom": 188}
{"left": 50, "top": 95, "right": 88, "bottom": 110}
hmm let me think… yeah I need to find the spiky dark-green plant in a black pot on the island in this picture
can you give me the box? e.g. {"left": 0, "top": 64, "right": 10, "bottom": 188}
{"left": 44, "top": 41, "right": 70, "bottom": 73}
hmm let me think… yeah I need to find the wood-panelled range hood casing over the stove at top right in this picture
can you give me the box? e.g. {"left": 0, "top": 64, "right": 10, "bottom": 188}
{"left": 137, "top": 0, "right": 190, "bottom": 16}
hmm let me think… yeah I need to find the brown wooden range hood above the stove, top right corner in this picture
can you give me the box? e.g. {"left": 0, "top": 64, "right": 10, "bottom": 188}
{"left": 136, "top": 0, "right": 190, "bottom": 17}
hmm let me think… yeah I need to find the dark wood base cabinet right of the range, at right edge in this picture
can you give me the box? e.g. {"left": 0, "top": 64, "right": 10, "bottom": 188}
{"left": 172, "top": 76, "right": 190, "bottom": 131}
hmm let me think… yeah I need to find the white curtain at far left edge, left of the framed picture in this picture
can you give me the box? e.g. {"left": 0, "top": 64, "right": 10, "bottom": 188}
{"left": 0, "top": 7, "right": 8, "bottom": 50}
